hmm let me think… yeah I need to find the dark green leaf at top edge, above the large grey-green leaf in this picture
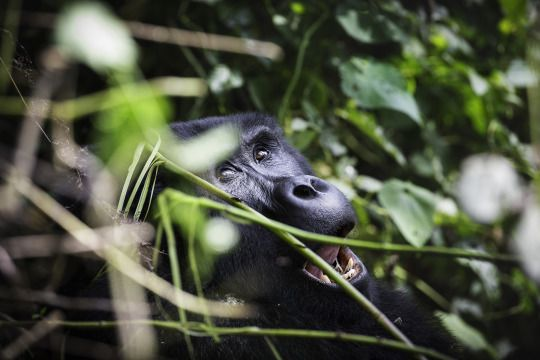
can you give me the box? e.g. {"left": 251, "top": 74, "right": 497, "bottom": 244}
{"left": 336, "top": 2, "right": 404, "bottom": 43}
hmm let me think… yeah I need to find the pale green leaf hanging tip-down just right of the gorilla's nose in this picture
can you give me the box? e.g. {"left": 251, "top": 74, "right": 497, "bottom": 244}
{"left": 378, "top": 180, "right": 436, "bottom": 247}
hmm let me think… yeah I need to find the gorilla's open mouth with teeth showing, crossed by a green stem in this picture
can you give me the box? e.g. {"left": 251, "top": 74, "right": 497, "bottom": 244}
{"left": 303, "top": 245, "right": 367, "bottom": 287}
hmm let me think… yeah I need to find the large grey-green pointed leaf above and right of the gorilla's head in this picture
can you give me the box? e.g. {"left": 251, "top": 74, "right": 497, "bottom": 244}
{"left": 339, "top": 58, "right": 422, "bottom": 124}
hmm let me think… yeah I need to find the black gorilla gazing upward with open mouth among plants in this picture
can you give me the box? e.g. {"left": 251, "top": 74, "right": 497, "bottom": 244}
{"left": 160, "top": 113, "right": 455, "bottom": 359}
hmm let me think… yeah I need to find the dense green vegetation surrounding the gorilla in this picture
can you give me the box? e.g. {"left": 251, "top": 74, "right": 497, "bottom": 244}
{"left": 0, "top": 0, "right": 540, "bottom": 359}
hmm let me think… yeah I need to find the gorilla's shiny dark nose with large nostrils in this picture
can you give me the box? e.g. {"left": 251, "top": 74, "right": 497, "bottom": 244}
{"left": 274, "top": 175, "right": 356, "bottom": 236}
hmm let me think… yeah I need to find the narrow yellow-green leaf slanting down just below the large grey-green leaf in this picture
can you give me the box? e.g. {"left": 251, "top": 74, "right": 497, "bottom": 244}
{"left": 336, "top": 104, "right": 407, "bottom": 166}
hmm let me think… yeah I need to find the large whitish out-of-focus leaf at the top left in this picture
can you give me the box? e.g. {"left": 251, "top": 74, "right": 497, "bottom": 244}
{"left": 55, "top": 2, "right": 137, "bottom": 72}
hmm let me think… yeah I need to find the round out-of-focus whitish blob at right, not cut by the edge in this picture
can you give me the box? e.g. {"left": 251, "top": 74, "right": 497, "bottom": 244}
{"left": 456, "top": 154, "right": 523, "bottom": 224}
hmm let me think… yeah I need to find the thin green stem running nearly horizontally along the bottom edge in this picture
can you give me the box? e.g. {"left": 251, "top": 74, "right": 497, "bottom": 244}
{"left": 0, "top": 319, "right": 452, "bottom": 360}
